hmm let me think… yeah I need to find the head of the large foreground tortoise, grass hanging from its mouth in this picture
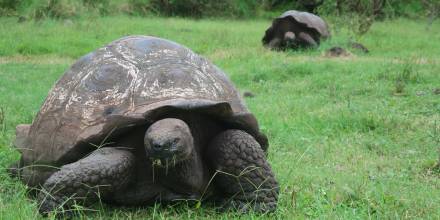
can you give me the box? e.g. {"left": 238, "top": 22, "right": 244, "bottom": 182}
{"left": 144, "top": 118, "right": 194, "bottom": 167}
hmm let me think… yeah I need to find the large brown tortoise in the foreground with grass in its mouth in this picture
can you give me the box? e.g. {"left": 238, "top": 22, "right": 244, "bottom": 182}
{"left": 8, "top": 36, "right": 278, "bottom": 214}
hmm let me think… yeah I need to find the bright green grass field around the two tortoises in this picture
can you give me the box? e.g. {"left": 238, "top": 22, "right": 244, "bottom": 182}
{"left": 0, "top": 17, "right": 440, "bottom": 219}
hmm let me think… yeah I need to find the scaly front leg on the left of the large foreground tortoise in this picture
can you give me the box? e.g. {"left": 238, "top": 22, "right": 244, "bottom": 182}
{"left": 37, "top": 148, "right": 135, "bottom": 214}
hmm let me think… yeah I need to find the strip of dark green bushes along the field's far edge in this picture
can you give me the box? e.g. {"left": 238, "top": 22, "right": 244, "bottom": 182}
{"left": 0, "top": 0, "right": 438, "bottom": 20}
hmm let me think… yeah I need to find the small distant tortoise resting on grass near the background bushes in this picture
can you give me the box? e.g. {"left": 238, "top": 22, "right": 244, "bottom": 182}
{"left": 262, "top": 10, "right": 330, "bottom": 49}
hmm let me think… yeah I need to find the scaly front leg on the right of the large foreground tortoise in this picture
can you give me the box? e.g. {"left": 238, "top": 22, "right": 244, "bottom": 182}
{"left": 207, "top": 129, "right": 279, "bottom": 212}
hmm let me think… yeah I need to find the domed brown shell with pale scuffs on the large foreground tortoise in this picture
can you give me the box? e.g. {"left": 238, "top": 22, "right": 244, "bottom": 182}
{"left": 16, "top": 36, "right": 268, "bottom": 166}
